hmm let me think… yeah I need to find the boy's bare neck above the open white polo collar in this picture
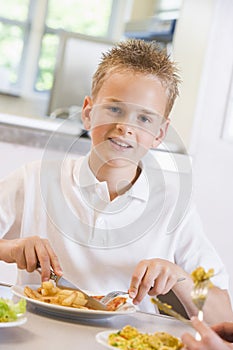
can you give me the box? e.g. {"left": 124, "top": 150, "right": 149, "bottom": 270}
{"left": 89, "top": 157, "right": 141, "bottom": 201}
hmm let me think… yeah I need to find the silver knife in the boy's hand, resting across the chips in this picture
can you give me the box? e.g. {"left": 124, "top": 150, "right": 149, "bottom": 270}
{"left": 37, "top": 266, "right": 107, "bottom": 311}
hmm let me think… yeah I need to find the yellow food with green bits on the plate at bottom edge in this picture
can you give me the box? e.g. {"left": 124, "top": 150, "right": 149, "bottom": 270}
{"left": 108, "top": 325, "right": 183, "bottom": 350}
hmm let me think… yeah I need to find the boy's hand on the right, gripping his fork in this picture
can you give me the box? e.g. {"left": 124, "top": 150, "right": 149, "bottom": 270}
{"left": 129, "top": 259, "right": 184, "bottom": 305}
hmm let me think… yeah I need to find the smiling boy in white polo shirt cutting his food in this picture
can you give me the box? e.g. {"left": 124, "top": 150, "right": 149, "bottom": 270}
{"left": 0, "top": 40, "right": 232, "bottom": 322}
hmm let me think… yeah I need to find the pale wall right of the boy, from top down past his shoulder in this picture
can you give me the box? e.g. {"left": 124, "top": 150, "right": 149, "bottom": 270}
{"left": 172, "top": 0, "right": 233, "bottom": 300}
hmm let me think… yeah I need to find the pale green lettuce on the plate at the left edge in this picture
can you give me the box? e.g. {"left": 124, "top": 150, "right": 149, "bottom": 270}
{"left": 0, "top": 298, "right": 26, "bottom": 322}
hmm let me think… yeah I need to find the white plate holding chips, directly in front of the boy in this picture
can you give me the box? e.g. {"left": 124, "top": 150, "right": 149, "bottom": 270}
{"left": 11, "top": 284, "right": 136, "bottom": 319}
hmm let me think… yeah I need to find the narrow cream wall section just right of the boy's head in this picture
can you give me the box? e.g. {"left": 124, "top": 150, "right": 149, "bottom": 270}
{"left": 171, "top": 0, "right": 214, "bottom": 150}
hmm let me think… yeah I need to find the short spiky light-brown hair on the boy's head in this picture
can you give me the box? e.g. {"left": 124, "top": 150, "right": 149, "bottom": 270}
{"left": 92, "top": 39, "right": 180, "bottom": 117}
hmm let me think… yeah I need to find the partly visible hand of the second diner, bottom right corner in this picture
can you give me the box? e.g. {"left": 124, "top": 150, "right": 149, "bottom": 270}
{"left": 181, "top": 317, "right": 233, "bottom": 350}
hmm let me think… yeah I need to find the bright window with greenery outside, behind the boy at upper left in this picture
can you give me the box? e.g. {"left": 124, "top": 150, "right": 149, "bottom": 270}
{"left": 0, "top": 0, "right": 126, "bottom": 94}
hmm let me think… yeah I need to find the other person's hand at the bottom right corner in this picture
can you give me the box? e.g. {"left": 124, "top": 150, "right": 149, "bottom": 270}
{"left": 181, "top": 317, "right": 233, "bottom": 350}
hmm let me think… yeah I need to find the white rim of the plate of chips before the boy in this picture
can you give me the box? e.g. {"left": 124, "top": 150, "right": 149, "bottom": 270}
{"left": 10, "top": 284, "right": 136, "bottom": 318}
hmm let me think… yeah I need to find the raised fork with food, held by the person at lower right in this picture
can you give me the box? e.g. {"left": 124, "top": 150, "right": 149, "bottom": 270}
{"left": 191, "top": 279, "right": 211, "bottom": 340}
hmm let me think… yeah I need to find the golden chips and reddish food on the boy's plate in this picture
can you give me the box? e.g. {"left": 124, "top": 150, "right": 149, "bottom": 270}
{"left": 24, "top": 281, "right": 127, "bottom": 311}
